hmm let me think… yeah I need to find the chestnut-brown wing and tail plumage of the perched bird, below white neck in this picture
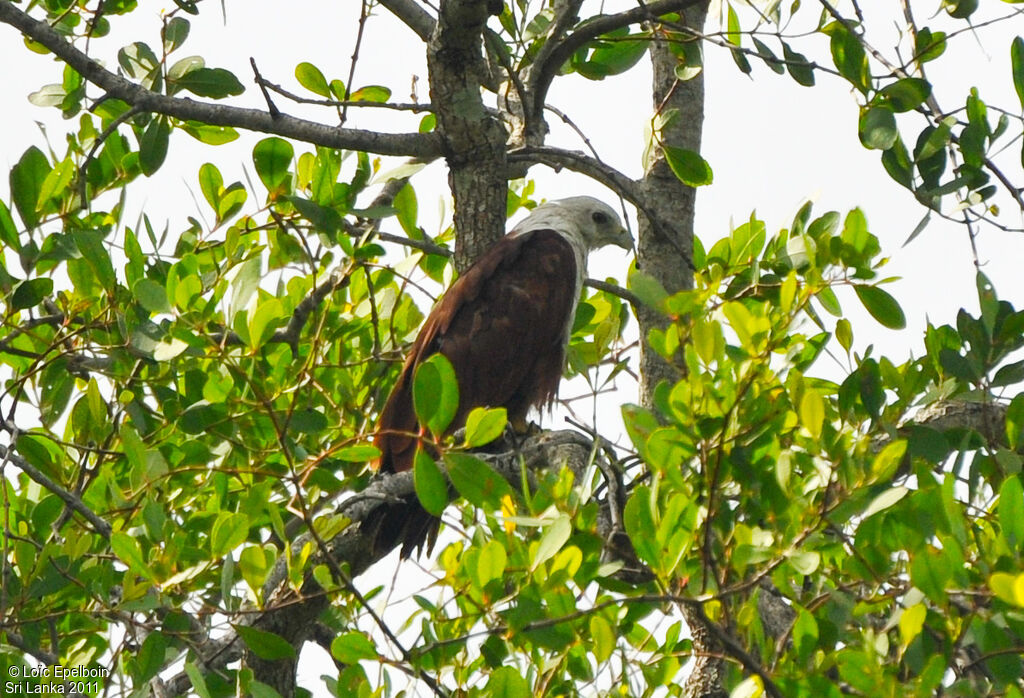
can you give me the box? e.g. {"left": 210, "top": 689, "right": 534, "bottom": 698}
{"left": 374, "top": 229, "right": 579, "bottom": 557}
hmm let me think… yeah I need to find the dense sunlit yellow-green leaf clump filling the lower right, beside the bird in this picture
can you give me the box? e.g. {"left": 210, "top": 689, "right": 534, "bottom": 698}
{"left": 625, "top": 206, "right": 1024, "bottom": 696}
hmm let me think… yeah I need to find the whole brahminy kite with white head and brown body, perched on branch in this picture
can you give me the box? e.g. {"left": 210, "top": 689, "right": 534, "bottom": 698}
{"left": 374, "top": 197, "right": 633, "bottom": 558}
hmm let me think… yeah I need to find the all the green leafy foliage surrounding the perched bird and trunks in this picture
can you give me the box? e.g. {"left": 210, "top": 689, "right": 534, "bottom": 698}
{"left": 0, "top": 0, "right": 1024, "bottom": 696}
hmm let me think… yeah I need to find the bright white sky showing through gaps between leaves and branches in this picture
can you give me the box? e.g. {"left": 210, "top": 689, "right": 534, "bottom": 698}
{"left": 0, "top": 0, "right": 1024, "bottom": 688}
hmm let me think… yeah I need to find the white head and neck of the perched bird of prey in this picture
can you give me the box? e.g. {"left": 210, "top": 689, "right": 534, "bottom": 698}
{"left": 512, "top": 197, "right": 633, "bottom": 252}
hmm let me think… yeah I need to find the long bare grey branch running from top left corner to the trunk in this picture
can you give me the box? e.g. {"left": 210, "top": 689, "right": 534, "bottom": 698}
{"left": 0, "top": 0, "right": 441, "bottom": 158}
